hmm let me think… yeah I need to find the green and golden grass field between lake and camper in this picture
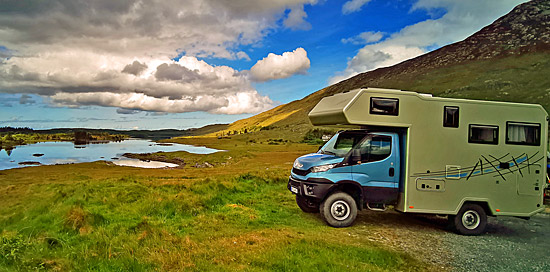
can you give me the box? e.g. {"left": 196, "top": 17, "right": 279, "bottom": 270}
{"left": 0, "top": 138, "right": 434, "bottom": 271}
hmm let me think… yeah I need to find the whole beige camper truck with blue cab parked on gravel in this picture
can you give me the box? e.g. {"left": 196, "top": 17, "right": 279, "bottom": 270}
{"left": 288, "top": 88, "right": 548, "bottom": 235}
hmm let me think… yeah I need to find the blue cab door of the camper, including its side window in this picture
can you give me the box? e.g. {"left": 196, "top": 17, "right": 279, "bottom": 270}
{"left": 351, "top": 133, "right": 400, "bottom": 189}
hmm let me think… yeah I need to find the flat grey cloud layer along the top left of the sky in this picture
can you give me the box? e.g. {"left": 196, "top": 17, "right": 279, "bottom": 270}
{"left": 0, "top": 0, "right": 316, "bottom": 59}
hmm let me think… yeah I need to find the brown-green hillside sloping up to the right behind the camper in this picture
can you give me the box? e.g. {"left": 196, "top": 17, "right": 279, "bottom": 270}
{"left": 210, "top": 0, "right": 550, "bottom": 141}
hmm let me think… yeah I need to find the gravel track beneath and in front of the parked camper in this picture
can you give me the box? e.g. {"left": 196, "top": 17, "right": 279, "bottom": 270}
{"left": 348, "top": 204, "right": 550, "bottom": 272}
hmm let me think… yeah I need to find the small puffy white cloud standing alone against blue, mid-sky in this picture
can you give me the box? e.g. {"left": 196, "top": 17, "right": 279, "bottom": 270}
{"left": 250, "top": 47, "right": 310, "bottom": 82}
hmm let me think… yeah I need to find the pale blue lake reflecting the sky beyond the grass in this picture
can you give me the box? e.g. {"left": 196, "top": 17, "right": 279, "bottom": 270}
{"left": 0, "top": 139, "right": 220, "bottom": 170}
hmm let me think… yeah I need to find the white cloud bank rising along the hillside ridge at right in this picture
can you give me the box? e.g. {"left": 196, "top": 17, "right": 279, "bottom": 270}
{"left": 329, "top": 0, "right": 525, "bottom": 84}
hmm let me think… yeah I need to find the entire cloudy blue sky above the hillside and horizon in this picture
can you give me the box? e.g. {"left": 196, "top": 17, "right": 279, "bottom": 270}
{"left": 0, "top": 0, "right": 525, "bottom": 130}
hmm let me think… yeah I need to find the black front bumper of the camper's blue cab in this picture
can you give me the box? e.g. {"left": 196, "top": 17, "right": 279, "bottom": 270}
{"left": 287, "top": 176, "right": 336, "bottom": 200}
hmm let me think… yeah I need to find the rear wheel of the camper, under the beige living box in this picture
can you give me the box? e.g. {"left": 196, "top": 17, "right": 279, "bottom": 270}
{"left": 449, "top": 204, "right": 487, "bottom": 235}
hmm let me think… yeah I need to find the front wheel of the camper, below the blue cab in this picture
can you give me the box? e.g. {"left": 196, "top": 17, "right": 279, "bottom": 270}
{"left": 321, "top": 192, "right": 357, "bottom": 228}
